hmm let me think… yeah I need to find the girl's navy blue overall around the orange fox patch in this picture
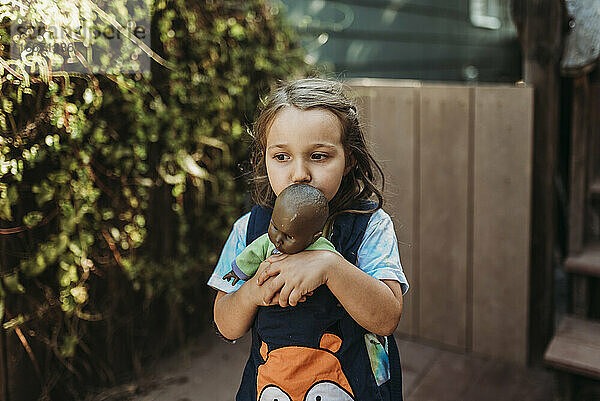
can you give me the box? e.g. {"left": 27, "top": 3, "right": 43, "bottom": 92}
{"left": 236, "top": 203, "right": 402, "bottom": 401}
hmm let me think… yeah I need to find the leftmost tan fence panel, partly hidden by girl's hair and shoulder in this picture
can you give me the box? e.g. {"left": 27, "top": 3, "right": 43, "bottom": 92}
{"left": 369, "top": 87, "right": 418, "bottom": 335}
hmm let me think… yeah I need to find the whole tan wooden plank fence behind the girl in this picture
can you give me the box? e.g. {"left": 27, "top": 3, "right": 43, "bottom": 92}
{"left": 350, "top": 79, "right": 533, "bottom": 364}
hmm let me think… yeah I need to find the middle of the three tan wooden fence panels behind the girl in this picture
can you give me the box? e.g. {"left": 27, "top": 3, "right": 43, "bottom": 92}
{"left": 418, "top": 86, "right": 469, "bottom": 349}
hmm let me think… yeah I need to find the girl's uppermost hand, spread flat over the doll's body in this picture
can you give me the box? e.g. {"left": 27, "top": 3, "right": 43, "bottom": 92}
{"left": 255, "top": 251, "right": 341, "bottom": 307}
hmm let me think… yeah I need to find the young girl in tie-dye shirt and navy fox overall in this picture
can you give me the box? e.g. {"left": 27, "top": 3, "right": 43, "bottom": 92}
{"left": 208, "top": 79, "right": 408, "bottom": 401}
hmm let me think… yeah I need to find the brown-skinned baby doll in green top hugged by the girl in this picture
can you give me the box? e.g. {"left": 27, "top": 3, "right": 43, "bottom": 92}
{"left": 223, "top": 183, "right": 337, "bottom": 285}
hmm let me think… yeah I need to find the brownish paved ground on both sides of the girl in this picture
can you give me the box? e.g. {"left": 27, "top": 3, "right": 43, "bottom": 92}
{"left": 89, "top": 332, "right": 555, "bottom": 401}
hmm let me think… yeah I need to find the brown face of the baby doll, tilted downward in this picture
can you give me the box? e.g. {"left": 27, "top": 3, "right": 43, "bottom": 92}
{"left": 268, "top": 199, "right": 321, "bottom": 254}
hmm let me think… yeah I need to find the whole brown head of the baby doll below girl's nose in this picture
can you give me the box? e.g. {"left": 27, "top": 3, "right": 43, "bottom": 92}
{"left": 268, "top": 183, "right": 329, "bottom": 254}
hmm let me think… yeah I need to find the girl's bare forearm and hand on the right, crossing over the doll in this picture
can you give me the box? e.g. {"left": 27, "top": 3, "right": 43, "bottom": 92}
{"left": 257, "top": 251, "right": 402, "bottom": 336}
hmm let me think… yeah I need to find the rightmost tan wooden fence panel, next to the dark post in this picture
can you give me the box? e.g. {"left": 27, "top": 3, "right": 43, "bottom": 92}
{"left": 472, "top": 87, "right": 533, "bottom": 364}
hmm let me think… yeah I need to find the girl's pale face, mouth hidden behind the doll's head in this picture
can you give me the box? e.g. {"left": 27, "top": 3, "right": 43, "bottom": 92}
{"left": 265, "top": 107, "right": 349, "bottom": 201}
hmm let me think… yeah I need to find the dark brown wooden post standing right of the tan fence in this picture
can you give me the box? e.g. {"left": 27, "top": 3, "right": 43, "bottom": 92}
{"left": 512, "top": 0, "right": 568, "bottom": 363}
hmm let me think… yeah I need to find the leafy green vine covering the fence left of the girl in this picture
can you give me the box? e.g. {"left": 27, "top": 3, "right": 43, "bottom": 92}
{"left": 0, "top": 0, "right": 304, "bottom": 399}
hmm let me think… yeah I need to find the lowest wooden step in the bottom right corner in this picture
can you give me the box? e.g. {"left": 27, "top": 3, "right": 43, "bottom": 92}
{"left": 544, "top": 316, "right": 600, "bottom": 379}
